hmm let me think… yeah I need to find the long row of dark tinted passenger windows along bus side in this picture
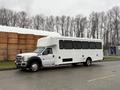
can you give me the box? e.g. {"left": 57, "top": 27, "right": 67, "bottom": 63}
{"left": 59, "top": 40, "right": 102, "bottom": 49}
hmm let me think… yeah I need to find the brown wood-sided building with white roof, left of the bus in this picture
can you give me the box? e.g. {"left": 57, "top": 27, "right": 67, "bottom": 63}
{"left": 0, "top": 26, "right": 60, "bottom": 60}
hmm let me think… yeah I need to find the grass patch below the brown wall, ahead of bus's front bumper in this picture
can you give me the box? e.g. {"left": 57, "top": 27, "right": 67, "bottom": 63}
{"left": 0, "top": 61, "right": 16, "bottom": 69}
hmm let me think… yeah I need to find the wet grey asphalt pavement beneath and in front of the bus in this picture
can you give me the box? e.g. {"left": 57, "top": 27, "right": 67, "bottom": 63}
{"left": 0, "top": 61, "right": 120, "bottom": 90}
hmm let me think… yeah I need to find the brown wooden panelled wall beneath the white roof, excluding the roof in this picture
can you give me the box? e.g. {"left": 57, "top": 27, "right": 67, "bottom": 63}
{"left": 0, "top": 32, "right": 43, "bottom": 60}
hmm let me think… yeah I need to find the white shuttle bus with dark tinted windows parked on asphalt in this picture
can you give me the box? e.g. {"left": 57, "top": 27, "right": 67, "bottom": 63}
{"left": 15, "top": 37, "right": 103, "bottom": 72}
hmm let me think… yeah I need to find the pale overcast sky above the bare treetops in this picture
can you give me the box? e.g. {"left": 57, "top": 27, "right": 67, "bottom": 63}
{"left": 0, "top": 0, "right": 120, "bottom": 16}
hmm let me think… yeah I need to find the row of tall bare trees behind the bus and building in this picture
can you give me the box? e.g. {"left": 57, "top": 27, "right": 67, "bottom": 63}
{"left": 0, "top": 6, "right": 120, "bottom": 48}
